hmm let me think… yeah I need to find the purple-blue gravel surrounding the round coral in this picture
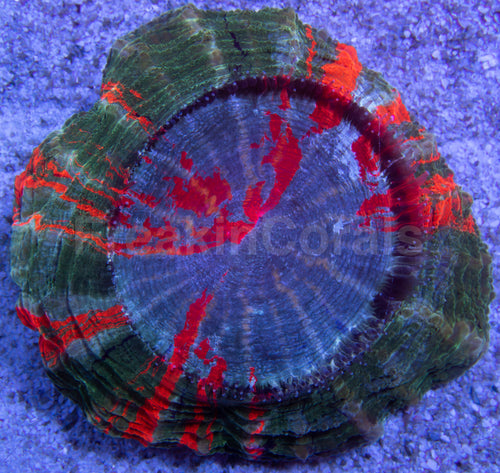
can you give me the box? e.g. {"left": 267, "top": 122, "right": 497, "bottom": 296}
{"left": 0, "top": 0, "right": 500, "bottom": 473}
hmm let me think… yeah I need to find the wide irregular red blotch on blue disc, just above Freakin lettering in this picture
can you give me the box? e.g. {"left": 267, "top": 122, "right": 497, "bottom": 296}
{"left": 163, "top": 171, "right": 233, "bottom": 218}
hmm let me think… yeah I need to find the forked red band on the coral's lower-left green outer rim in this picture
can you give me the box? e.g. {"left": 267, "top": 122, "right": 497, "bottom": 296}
{"left": 16, "top": 305, "right": 128, "bottom": 368}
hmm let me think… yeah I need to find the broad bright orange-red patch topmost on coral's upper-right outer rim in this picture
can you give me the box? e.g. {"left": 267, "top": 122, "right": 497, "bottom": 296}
{"left": 321, "top": 43, "right": 363, "bottom": 99}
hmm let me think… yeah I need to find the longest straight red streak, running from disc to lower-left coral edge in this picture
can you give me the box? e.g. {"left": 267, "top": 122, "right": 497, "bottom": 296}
{"left": 123, "top": 289, "right": 213, "bottom": 445}
